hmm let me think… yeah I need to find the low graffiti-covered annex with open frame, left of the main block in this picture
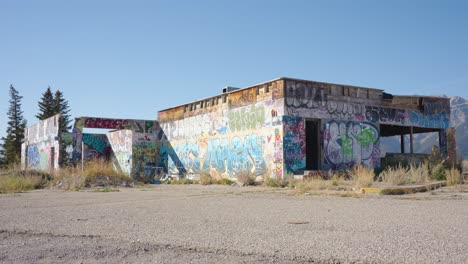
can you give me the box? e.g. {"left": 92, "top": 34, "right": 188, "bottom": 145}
{"left": 72, "top": 117, "right": 165, "bottom": 179}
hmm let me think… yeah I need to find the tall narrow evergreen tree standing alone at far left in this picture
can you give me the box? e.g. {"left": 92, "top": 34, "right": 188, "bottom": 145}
{"left": 2, "top": 85, "right": 26, "bottom": 164}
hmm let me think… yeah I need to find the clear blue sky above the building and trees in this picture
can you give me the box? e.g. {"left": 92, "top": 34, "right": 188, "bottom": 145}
{"left": 0, "top": 0, "right": 468, "bottom": 136}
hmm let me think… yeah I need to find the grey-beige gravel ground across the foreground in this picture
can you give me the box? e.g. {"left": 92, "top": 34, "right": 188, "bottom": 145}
{"left": 0, "top": 185, "right": 468, "bottom": 263}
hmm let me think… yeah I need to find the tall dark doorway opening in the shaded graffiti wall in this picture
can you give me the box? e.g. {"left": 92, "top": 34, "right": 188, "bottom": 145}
{"left": 306, "top": 120, "right": 320, "bottom": 170}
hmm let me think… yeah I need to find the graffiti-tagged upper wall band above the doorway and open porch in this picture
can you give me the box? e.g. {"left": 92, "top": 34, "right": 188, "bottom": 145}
{"left": 285, "top": 80, "right": 450, "bottom": 129}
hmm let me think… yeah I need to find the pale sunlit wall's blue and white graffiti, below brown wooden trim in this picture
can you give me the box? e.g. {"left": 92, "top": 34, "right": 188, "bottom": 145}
{"left": 160, "top": 99, "right": 283, "bottom": 178}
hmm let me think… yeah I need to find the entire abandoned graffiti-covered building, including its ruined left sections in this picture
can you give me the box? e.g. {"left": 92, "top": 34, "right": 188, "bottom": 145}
{"left": 23, "top": 78, "right": 455, "bottom": 178}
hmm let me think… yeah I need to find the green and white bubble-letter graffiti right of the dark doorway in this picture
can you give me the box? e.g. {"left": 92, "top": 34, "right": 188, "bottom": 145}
{"left": 323, "top": 121, "right": 380, "bottom": 170}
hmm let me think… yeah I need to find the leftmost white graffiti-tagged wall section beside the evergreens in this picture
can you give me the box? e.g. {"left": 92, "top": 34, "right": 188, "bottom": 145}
{"left": 21, "top": 115, "right": 60, "bottom": 171}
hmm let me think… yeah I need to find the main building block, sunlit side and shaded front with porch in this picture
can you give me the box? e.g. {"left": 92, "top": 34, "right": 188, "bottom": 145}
{"left": 158, "top": 78, "right": 455, "bottom": 178}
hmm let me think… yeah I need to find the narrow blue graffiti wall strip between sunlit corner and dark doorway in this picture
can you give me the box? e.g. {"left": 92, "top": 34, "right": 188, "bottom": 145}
{"left": 283, "top": 116, "right": 306, "bottom": 173}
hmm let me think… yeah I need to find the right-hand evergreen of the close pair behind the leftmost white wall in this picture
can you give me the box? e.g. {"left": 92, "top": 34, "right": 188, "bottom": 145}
{"left": 53, "top": 90, "right": 71, "bottom": 164}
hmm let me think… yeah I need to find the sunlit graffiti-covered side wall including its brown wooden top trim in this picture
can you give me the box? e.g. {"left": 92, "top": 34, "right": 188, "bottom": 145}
{"left": 158, "top": 81, "right": 284, "bottom": 178}
